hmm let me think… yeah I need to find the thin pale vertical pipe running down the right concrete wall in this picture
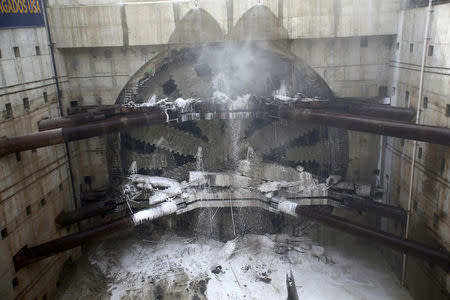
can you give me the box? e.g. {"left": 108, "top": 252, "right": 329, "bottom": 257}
{"left": 402, "top": 0, "right": 433, "bottom": 287}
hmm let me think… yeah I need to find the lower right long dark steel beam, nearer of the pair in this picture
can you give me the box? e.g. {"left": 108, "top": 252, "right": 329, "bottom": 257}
{"left": 295, "top": 205, "right": 450, "bottom": 272}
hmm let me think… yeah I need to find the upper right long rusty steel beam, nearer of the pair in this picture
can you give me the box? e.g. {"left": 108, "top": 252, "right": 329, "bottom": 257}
{"left": 278, "top": 106, "right": 450, "bottom": 146}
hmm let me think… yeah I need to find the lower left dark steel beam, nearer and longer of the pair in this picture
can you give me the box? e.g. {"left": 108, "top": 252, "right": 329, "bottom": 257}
{"left": 13, "top": 216, "right": 132, "bottom": 271}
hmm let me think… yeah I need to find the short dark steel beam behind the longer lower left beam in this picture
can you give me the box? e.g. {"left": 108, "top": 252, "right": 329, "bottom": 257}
{"left": 55, "top": 201, "right": 123, "bottom": 226}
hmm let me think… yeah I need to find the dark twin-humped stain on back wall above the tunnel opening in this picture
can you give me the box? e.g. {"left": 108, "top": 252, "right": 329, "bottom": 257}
{"left": 129, "top": 5, "right": 334, "bottom": 102}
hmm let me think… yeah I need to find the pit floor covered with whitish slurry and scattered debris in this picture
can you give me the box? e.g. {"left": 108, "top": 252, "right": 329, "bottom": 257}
{"left": 57, "top": 224, "right": 411, "bottom": 299}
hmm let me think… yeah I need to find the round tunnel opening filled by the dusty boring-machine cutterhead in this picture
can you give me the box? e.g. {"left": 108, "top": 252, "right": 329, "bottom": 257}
{"left": 108, "top": 42, "right": 349, "bottom": 246}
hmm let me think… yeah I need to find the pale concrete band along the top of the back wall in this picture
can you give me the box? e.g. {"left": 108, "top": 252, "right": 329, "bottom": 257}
{"left": 49, "top": 0, "right": 401, "bottom": 48}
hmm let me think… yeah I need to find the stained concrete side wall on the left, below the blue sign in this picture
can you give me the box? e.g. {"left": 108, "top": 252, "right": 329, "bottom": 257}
{"left": 0, "top": 27, "right": 80, "bottom": 299}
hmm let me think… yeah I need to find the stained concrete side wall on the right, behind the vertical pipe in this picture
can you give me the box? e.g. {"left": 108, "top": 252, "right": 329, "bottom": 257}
{"left": 382, "top": 4, "right": 450, "bottom": 299}
